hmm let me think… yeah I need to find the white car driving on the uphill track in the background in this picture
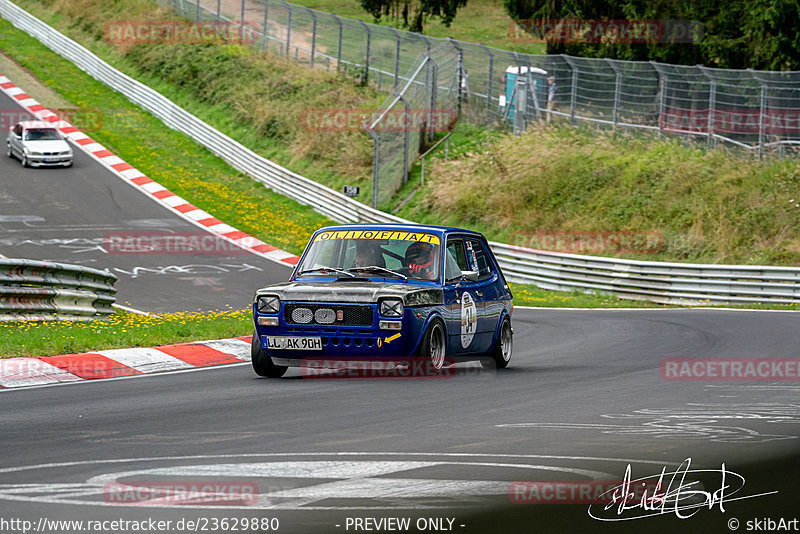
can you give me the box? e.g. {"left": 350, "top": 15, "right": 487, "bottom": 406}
{"left": 6, "top": 121, "right": 72, "bottom": 167}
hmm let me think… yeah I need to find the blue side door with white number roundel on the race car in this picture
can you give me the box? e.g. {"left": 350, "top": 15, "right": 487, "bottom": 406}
{"left": 444, "top": 236, "right": 485, "bottom": 355}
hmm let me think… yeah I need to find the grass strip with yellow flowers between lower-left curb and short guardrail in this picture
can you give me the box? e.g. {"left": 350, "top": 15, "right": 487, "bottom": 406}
{"left": 0, "top": 309, "right": 253, "bottom": 358}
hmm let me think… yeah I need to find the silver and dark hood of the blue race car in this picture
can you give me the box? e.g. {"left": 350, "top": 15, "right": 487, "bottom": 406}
{"left": 256, "top": 282, "right": 444, "bottom": 306}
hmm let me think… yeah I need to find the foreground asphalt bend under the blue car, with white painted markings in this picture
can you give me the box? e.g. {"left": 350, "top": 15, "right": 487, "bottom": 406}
{"left": 0, "top": 309, "right": 800, "bottom": 532}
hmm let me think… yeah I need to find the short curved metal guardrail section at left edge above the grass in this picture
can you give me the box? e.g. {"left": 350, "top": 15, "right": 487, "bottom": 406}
{"left": 0, "top": 258, "right": 117, "bottom": 321}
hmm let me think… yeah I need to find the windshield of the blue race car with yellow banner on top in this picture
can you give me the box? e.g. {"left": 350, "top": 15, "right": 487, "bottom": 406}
{"left": 296, "top": 229, "right": 441, "bottom": 281}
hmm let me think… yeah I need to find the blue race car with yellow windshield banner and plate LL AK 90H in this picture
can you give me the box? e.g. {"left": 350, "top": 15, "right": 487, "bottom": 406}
{"left": 252, "top": 224, "right": 513, "bottom": 378}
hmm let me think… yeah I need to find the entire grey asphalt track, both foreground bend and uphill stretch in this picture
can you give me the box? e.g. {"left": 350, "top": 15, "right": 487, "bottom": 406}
{"left": 0, "top": 81, "right": 800, "bottom": 534}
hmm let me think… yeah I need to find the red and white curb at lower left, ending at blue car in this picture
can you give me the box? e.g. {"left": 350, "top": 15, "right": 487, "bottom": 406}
{"left": 0, "top": 336, "right": 251, "bottom": 389}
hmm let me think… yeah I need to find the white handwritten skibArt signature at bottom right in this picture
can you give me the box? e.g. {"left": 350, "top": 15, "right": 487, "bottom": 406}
{"left": 589, "top": 458, "right": 778, "bottom": 521}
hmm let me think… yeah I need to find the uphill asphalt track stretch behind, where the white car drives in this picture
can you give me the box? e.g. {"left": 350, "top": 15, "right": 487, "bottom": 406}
{"left": 0, "top": 89, "right": 290, "bottom": 312}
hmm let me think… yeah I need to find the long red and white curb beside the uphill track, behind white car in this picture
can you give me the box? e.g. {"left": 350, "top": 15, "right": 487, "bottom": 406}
{"left": 0, "top": 73, "right": 300, "bottom": 266}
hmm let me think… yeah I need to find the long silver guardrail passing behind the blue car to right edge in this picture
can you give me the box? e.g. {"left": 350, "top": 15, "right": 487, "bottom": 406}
{"left": 0, "top": 0, "right": 800, "bottom": 304}
